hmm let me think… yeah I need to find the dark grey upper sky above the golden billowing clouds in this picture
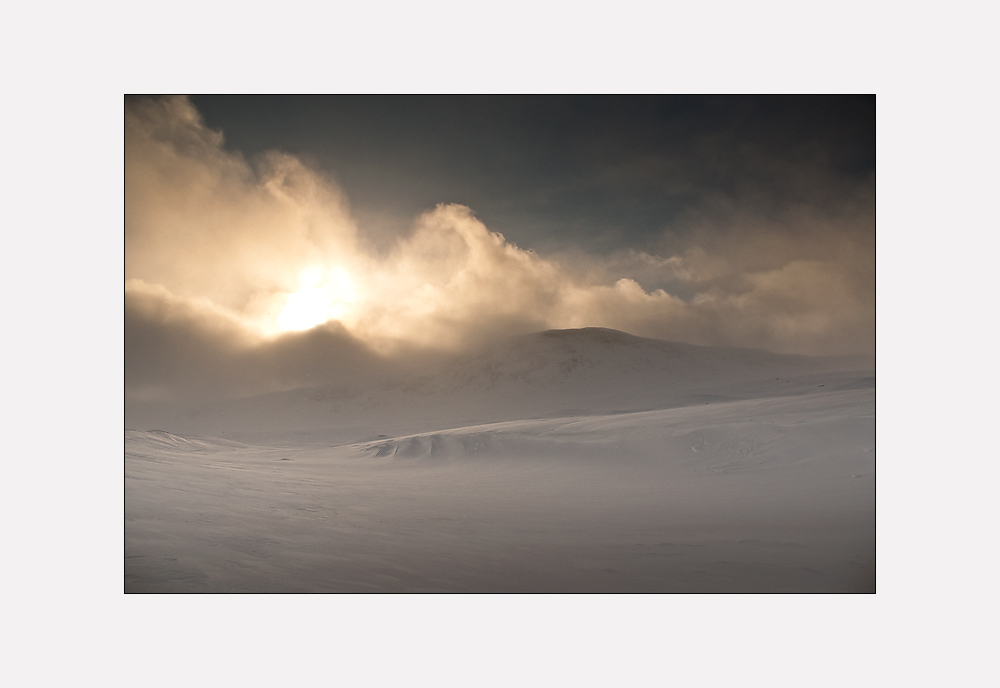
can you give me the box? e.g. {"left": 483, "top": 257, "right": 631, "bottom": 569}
{"left": 193, "top": 96, "right": 875, "bottom": 250}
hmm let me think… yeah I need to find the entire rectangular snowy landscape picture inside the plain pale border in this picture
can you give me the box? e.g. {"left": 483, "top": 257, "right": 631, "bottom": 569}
{"left": 124, "top": 97, "right": 876, "bottom": 593}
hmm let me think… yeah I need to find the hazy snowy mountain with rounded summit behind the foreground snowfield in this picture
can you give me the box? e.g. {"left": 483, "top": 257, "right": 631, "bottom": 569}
{"left": 126, "top": 328, "right": 874, "bottom": 439}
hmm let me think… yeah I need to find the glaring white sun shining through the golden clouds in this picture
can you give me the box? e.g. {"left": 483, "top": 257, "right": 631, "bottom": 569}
{"left": 278, "top": 267, "right": 355, "bottom": 332}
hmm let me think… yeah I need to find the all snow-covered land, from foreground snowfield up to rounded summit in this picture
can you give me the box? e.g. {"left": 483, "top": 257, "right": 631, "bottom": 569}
{"left": 125, "top": 329, "right": 875, "bottom": 592}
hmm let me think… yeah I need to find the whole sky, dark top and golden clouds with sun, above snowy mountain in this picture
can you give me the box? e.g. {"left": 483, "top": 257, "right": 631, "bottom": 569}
{"left": 125, "top": 96, "right": 875, "bottom": 397}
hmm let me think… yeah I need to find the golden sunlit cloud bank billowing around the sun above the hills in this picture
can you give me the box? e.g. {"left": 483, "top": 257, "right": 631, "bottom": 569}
{"left": 125, "top": 98, "right": 875, "bottom": 394}
